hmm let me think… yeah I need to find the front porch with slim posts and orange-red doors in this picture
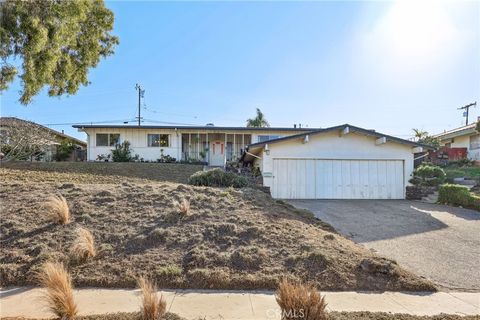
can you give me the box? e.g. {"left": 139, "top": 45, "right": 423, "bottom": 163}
{"left": 181, "top": 133, "right": 252, "bottom": 166}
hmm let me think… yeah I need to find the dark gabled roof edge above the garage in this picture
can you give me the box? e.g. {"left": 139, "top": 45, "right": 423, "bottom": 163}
{"left": 248, "top": 123, "right": 435, "bottom": 150}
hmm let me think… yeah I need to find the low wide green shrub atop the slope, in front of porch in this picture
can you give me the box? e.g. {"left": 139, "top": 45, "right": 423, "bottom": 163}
{"left": 188, "top": 168, "right": 248, "bottom": 188}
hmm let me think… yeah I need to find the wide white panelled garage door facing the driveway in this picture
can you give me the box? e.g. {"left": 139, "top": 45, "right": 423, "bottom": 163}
{"left": 272, "top": 159, "right": 404, "bottom": 199}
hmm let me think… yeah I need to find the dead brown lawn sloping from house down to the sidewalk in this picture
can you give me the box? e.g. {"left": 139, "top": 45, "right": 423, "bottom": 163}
{"left": 0, "top": 169, "right": 435, "bottom": 291}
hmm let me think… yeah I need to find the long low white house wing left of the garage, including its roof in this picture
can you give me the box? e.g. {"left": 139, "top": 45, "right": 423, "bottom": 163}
{"left": 73, "top": 125, "right": 314, "bottom": 166}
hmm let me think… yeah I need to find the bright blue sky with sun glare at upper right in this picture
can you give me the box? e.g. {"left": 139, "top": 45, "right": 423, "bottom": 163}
{"left": 0, "top": 0, "right": 480, "bottom": 139}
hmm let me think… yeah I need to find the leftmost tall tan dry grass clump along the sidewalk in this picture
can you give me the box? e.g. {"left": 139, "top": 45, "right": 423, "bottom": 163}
{"left": 38, "top": 262, "right": 78, "bottom": 320}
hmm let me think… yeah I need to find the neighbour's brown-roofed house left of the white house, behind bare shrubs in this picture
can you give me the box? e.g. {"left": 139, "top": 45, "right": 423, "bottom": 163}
{"left": 0, "top": 117, "right": 87, "bottom": 161}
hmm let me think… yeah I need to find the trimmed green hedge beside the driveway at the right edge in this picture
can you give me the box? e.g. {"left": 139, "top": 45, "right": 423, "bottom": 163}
{"left": 438, "top": 184, "right": 480, "bottom": 211}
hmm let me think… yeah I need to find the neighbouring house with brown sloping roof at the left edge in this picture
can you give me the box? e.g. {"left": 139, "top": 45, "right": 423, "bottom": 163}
{"left": 0, "top": 117, "right": 87, "bottom": 161}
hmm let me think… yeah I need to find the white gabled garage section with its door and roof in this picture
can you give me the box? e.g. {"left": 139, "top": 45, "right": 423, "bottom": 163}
{"left": 241, "top": 124, "right": 430, "bottom": 199}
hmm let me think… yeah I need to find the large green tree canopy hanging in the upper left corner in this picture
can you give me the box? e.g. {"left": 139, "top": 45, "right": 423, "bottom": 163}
{"left": 0, "top": 0, "right": 118, "bottom": 104}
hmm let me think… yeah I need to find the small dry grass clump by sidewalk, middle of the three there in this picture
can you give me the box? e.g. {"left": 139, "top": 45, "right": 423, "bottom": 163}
{"left": 138, "top": 277, "right": 167, "bottom": 320}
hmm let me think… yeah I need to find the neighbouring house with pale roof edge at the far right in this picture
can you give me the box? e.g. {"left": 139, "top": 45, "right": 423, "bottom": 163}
{"left": 435, "top": 123, "right": 480, "bottom": 160}
